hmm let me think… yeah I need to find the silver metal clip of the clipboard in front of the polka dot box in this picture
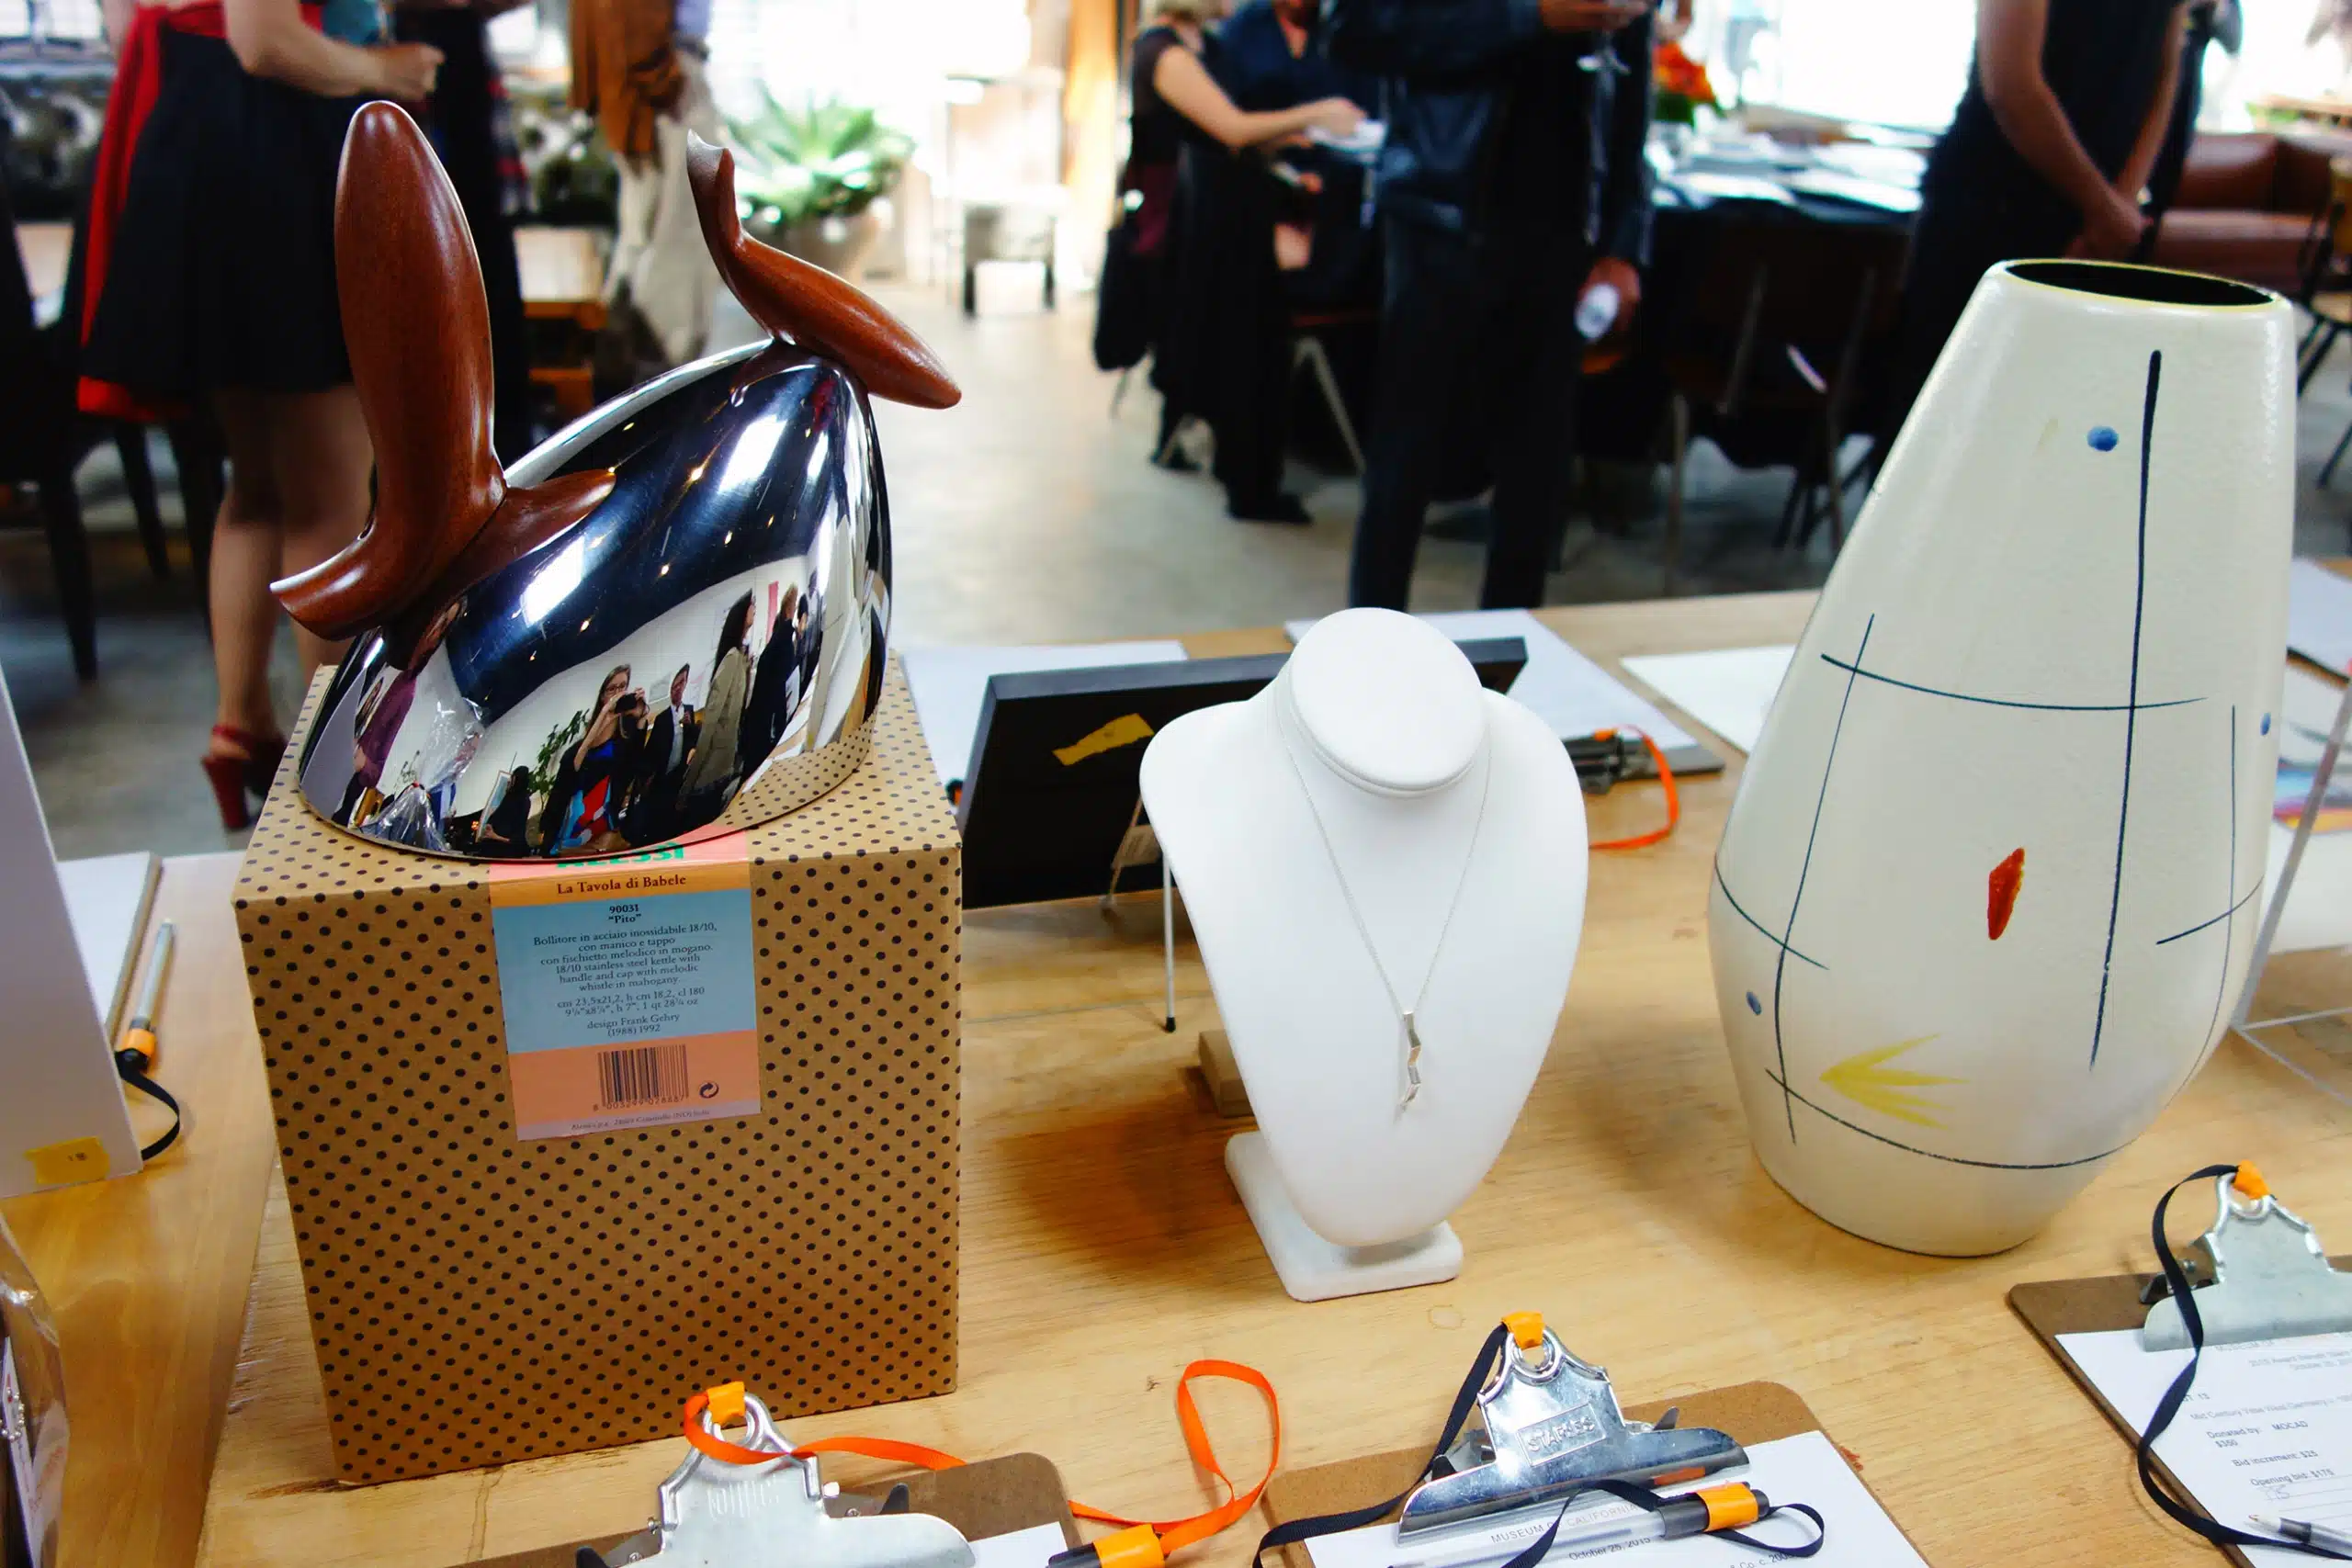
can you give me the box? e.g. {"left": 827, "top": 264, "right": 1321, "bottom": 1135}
{"left": 579, "top": 1394, "right": 974, "bottom": 1568}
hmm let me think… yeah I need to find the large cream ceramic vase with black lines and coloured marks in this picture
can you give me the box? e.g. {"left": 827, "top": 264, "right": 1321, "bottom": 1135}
{"left": 1708, "top": 261, "right": 2296, "bottom": 1256}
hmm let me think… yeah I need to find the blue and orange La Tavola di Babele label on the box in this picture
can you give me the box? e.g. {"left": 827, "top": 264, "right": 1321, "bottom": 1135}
{"left": 489, "top": 832, "right": 760, "bottom": 1143}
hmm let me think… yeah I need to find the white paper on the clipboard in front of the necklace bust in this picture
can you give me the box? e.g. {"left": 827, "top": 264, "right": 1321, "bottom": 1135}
{"left": 1307, "top": 1432, "right": 1927, "bottom": 1568}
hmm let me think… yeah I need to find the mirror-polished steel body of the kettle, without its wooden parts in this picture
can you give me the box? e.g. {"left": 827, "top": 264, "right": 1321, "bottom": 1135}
{"left": 301, "top": 339, "right": 891, "bottom": 861}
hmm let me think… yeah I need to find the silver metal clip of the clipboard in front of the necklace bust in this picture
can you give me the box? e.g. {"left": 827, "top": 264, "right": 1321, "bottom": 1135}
{"left": 1397, "top": 1312, "right": 1747, "bottom": 1540}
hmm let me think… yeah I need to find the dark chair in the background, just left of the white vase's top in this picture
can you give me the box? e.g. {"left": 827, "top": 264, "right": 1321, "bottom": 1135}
{"left": 1663, "top": 211, "right": 1910, "bottom": 592}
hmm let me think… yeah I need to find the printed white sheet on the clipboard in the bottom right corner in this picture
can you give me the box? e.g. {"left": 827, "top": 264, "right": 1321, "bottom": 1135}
{"left": 2058, "top": 1328, "right": 2352, "bottom": 1568}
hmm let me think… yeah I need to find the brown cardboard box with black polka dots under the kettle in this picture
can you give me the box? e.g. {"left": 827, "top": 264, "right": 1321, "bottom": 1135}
{"left": 238, "top": 668, "right": 962, "bottom": 1481}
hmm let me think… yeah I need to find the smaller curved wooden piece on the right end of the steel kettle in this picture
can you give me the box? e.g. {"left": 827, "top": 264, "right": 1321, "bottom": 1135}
{"left": 687, "top": 131, "right": 965, "bottom": 409}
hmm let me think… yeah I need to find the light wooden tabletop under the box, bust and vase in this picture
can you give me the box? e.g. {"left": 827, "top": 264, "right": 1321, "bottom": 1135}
{"left": 32, "top": 594, "right": 2352, "bottom": 1568}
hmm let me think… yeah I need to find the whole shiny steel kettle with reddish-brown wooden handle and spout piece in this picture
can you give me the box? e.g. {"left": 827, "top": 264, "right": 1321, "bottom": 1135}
{"left": 276, "top": 104, "right": 959, "bottom": 861}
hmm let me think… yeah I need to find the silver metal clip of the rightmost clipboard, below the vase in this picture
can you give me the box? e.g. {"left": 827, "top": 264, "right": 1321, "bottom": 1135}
{"left": 2141, "top": 1176, "right": 2352, "bottom": 1349}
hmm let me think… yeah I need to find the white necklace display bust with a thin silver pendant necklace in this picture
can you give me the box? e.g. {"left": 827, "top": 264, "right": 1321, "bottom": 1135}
{"left": 1143, "top": 609, "right": 1585, "bottom": 1300}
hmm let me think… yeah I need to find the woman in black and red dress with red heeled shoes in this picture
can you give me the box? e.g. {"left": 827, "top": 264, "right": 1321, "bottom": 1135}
{"left": 83, "top": 0, "right": 440, "bottom": 828}
